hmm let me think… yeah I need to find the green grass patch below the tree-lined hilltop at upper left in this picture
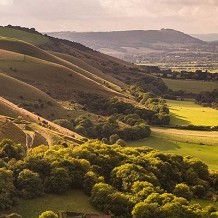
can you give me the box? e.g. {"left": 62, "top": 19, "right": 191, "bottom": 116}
{"left": 0, "top": 27, "right": 49, "bottom": 45}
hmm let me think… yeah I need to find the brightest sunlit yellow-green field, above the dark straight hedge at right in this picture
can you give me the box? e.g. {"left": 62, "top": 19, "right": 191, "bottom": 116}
{"left": 167, "top": 100, "right": 218, "bottom": 126}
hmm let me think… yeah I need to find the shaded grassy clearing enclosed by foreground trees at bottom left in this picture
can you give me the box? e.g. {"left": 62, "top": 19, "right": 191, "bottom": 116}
{"left": 8, "top": 190, "right": 100, "bottom": 218}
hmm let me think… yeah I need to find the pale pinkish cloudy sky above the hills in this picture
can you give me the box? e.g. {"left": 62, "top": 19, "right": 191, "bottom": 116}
{"left": 0, "top": 0, "right": 218, "bottom": 34}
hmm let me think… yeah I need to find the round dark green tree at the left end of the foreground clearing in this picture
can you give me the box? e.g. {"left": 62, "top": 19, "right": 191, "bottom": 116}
{"left": 17, "top": 169, "right": 44, "bottom": 198}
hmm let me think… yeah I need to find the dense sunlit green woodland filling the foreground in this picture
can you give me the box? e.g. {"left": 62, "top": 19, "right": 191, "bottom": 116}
{"left": 0, "top": 140, "right": 218, "bottom": 218}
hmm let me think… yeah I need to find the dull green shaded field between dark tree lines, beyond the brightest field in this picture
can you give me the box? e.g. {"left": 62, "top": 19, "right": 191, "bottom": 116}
{"left": 163, "top": 79, "right": 218, "bottom": 93}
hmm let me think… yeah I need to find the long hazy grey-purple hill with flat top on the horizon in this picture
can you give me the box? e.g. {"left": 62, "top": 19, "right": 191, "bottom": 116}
{"left": 48, "top": 29, "right": 202, "bottom": 50}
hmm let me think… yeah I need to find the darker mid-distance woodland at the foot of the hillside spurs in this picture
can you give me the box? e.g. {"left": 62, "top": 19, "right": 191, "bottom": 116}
{"left": 54, "top": 92, "right": 170, "bottom": 144}
